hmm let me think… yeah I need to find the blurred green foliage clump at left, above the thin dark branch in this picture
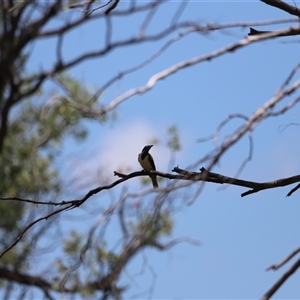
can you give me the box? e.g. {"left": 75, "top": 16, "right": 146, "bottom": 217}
{"left": 0, "top": 75, "right": 96, "bottom": 197}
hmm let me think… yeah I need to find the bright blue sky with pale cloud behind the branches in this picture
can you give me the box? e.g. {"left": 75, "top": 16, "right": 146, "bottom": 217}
{"left": 25, "top": 1, "right": 300, "bottom": 299}
